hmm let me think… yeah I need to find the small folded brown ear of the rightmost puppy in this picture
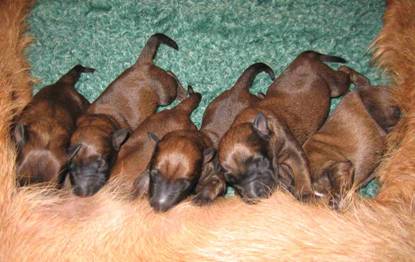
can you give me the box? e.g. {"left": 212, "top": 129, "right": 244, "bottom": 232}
{"left": 324, "top": 161, "right": 354, "bottom": 196}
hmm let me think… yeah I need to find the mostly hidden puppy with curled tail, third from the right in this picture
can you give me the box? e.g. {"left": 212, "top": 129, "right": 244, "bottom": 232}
{"left": 193, "top": 63, "right": 275, "bottom": 205}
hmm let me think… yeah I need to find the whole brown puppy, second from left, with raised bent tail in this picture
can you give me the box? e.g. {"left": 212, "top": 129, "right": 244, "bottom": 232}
{"left": 69, "top": 34, "right": 182, "bottom": 196}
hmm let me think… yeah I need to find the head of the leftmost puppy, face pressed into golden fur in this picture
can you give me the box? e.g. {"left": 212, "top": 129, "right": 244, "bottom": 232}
{"left": 12, "top": 123, "right": 69, "bottom": 186}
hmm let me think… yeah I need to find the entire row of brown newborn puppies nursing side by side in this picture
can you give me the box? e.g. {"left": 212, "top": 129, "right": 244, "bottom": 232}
{"left": 11, "top": 33, "right": 401, "bottom": 211}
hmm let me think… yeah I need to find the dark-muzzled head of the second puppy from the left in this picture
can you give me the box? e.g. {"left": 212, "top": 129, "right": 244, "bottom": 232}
{"left": 68, "top": 116, "right": 129, "bottom": 196}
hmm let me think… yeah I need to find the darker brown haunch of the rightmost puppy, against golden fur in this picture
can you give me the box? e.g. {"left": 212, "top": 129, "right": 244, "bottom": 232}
{"left": 358, "top": 87, "right": 401, "bottom": 132}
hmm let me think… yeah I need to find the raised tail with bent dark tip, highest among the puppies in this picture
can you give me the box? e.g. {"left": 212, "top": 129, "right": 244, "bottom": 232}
{"left": 137, "top": 33, "right": 179, "bottom": 64}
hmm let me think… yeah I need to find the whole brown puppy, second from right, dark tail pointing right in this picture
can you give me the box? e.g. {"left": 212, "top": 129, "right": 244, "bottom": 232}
{"left": 219, "top": 51, "right": 350, "bottom": 202}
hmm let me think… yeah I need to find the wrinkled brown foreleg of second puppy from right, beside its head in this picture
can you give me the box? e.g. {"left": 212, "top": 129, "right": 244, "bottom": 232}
{"left": 271, "top": 127, "right": 314, "bottom": 199}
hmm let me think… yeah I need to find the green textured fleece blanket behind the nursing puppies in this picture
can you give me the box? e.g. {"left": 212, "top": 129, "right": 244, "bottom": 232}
{"left": 28, "top": 0, "right": 385, "bottom": 195}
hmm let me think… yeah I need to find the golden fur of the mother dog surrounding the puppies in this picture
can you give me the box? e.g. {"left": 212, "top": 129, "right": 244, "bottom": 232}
{"left": 0, "top": 0, "right": 415, "bottom": 261}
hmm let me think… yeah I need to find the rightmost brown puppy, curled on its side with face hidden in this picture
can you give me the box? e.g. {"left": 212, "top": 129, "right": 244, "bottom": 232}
{"left": 303, "top": 67, "right": 400, "bottom": 206}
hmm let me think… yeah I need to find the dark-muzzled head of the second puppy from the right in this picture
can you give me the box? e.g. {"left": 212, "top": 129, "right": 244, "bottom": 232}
{"left": 219, "top": 113, "right": 277, "bottom": 203}
